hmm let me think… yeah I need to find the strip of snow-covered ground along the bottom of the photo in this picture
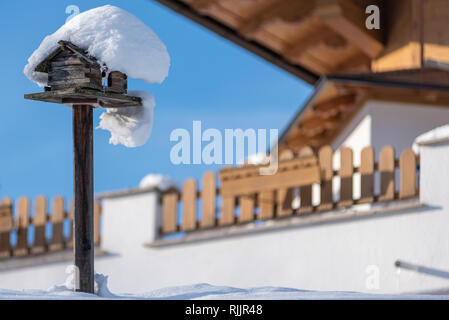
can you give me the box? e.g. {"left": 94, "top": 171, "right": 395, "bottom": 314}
{"left": 0, "top": 284, "right": 449, "bottom": 300}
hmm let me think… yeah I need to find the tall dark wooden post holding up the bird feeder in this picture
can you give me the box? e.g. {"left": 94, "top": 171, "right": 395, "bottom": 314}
{"left": 72, "top": 105, "right": 94, "bottom": 293}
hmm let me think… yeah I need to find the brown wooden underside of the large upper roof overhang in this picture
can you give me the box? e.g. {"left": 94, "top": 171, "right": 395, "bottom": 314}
{"left": 157, "top": 0, "right": 385, "bottom": 84}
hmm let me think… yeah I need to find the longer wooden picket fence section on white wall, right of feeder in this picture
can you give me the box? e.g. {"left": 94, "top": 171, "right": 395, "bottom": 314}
{"left": 161, "top": 146, "right": 419, "bottom": 234}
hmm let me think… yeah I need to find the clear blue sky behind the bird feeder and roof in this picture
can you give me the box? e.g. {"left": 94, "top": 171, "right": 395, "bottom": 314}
{"left": 0, "top": 0, "right": 312, "bottom": 199}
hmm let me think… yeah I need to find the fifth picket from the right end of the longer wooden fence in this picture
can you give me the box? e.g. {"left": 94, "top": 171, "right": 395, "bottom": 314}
{"left": 318, "top": 146, "right": 334, "bottom": 211}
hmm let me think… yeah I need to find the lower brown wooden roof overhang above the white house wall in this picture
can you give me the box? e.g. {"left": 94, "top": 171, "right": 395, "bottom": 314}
{"left": 279, "top": 65, "right": 449, "bottom": 153}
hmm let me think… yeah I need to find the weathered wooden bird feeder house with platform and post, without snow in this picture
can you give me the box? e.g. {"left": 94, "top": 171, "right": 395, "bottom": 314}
{"left": 23, "top": 41, "right": 142, "bottom": 293}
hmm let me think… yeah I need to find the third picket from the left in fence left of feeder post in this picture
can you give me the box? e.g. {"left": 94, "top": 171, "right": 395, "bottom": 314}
{"left": 31, "top": 196, "right": 47, "bottom": 254}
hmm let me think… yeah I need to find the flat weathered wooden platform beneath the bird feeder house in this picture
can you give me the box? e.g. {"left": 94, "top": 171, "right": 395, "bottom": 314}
{"left": 24, "top": 88, "right": 142, "bottom": 108}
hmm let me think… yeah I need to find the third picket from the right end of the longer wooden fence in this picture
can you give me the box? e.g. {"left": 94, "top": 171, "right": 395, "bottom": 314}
{"left": 358, "top": 147, "right": 374, "bottom": 203}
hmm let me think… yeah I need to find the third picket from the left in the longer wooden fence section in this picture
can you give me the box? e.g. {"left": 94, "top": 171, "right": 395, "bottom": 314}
{"left": 200, "top": 172, "right": 217, "bottom": 228}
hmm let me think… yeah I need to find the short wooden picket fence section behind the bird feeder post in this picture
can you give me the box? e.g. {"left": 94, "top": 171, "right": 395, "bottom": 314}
{"left": 0, "top": 196, "right": 101, "bottom": 259}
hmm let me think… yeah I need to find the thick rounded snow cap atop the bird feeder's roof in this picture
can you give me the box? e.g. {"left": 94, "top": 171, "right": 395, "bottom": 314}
{"left": 24, "top": 5, "right": 170, "bottom": 86}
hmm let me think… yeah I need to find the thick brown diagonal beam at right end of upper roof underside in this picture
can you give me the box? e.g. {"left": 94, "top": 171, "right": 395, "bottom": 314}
{"left": 314, "top": 0, "right": 384, "bottom": 58}
